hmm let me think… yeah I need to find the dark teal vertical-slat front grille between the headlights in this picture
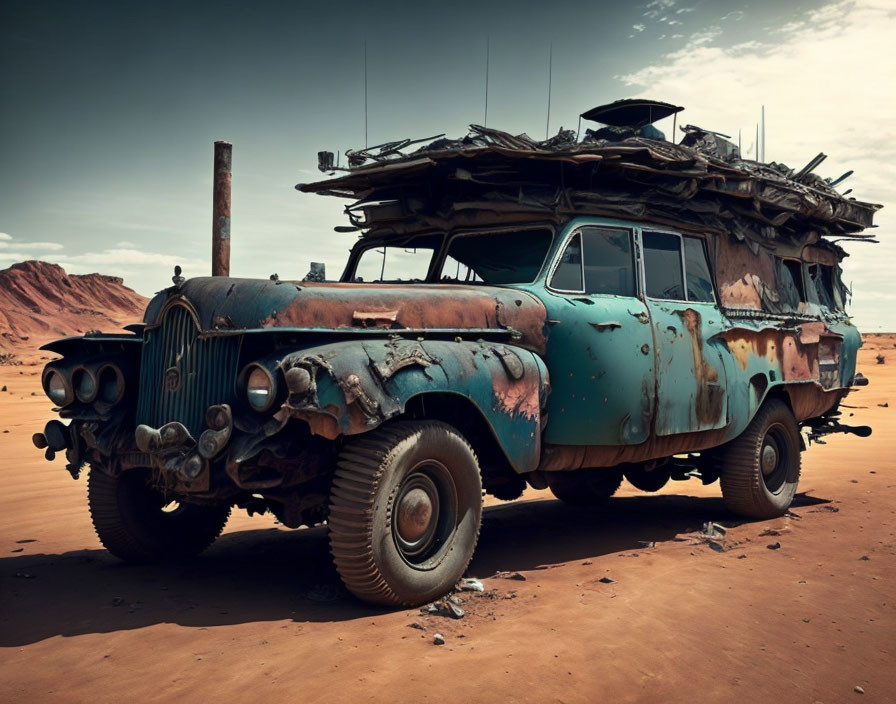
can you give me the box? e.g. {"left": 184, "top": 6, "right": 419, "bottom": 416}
{"left": 137, "top": 305, "right": 239, "bottom": 438}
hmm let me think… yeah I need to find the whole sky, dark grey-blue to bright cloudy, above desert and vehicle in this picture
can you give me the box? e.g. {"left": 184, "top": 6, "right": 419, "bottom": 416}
{"left": 0, "top": 0, "right": 896, "bottom": 331}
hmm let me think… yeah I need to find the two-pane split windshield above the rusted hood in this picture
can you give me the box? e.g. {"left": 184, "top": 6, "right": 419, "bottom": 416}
{"left": 351, "top": 228, "right": 553, "bottom": 285}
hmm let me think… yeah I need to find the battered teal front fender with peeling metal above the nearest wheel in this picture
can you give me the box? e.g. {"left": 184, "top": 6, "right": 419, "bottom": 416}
{"left": 270, "top": 337, "right": 550, "bottom": 472}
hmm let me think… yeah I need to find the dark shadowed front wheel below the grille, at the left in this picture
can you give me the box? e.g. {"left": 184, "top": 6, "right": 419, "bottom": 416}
{"left": 87, "top": 469, "right": 230, "bottom": 562}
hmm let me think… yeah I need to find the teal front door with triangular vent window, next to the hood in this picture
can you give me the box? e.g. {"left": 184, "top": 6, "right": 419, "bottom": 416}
{"left": 539, "top": 225, "right": 655, "bottom": 445}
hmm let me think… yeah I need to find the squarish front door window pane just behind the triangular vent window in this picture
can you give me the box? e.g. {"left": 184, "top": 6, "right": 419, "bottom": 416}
{"left": 582, "top": 227, "right": 635, "bottom": 296}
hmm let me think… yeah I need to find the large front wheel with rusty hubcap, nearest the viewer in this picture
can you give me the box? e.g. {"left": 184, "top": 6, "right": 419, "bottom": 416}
{"left": 328, "top": 421, "right": 482, "bottom": 606}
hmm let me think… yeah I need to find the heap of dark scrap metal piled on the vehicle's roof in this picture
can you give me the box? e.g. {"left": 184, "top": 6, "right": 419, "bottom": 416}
{"left": 296, "top": 101, "right": 880, "bottom": 247}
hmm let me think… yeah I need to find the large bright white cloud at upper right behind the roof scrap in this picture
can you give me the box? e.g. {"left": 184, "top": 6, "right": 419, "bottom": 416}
{"left": 621, "top": 0, "right": 896, "bottom": 330}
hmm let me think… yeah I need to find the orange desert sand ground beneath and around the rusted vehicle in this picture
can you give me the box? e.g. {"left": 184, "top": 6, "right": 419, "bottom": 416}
{"left": 0, "top": 336, "right": 896, "bottom": 703}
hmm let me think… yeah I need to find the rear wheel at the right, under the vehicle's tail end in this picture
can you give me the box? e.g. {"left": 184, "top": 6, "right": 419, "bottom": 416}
{"left": 718, "top": 399, "right": 801, "bottom": 518}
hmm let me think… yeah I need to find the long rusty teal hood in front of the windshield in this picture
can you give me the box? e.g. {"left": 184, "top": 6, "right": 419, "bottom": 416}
{"left": 144, "top": 277, "right": 547, "bottom": 350}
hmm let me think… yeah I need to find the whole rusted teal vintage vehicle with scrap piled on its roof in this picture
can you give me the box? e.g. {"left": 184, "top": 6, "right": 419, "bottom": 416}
{"left": 35, "top": 101, "right": 878, "bottom": 605}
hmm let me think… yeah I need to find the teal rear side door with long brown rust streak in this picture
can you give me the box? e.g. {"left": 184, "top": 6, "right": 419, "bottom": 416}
{"left": 641, "top": 228, "right": 728, "bottom": 436}
